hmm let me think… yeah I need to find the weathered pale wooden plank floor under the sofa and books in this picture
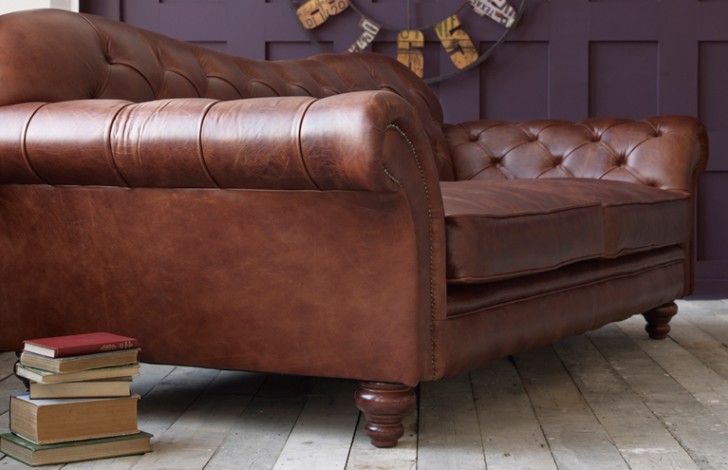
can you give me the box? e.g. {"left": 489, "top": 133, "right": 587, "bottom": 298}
{"left": 0, "top": 300, "right": 728, "bottom": 470}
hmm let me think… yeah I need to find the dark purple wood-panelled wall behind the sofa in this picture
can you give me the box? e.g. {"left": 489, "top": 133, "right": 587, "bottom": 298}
{"left": 81, "top": 0, "right": 728, "bottom": 297}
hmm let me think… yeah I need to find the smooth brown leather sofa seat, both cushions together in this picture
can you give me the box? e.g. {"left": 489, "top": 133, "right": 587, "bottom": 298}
{"left": 441, "top": 178, "right": 690, "bottom": 284}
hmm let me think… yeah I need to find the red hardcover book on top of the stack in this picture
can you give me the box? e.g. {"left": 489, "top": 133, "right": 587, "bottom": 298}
{"left": 23, "top": 332, "right": 139, "bottom": 357}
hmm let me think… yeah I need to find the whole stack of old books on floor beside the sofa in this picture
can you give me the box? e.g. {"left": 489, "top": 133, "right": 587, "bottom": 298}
{"left": 0, "top": 333, "right": 152, "bottom": 465}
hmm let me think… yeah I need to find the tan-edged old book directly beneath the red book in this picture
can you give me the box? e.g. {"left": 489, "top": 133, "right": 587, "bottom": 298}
{"left": 20, "top": 348, "right": 139, "bottom": 373}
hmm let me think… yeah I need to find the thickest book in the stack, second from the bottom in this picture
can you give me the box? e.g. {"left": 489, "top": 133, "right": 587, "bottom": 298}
{"left": 10, "top": 393, "right": 139, "bottom": 444}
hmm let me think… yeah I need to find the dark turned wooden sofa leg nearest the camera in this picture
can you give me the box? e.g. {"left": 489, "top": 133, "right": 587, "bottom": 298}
{"left": 355, "top": 382, "right": 417, "bottom": 447}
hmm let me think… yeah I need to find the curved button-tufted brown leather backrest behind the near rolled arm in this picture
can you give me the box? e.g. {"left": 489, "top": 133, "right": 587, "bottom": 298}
{"left": 0, "top": 10, "right": 452, "bottom": 179}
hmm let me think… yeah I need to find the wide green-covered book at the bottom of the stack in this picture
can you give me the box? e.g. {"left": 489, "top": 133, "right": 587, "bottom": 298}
{"left": 0, "top": 431, "right": 152, "bottom": 466}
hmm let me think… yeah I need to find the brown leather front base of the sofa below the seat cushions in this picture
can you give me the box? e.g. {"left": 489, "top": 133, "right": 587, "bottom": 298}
{"left": 429, "top": 248, "right": 685, "bottom": 379}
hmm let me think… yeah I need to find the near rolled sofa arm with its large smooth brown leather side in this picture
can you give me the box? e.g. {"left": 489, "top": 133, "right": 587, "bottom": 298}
{"left": 0, "top": 82, "right": 445, "bottom": 384}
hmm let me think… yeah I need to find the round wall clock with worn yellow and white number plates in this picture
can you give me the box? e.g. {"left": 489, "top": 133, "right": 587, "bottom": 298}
{"left": 289, "top": 0, "right": 525, "bottom": 83}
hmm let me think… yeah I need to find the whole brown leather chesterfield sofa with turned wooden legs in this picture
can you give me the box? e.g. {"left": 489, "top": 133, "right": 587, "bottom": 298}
{"left": 0, "top": 10, "right": 708, "bottom": 446}
